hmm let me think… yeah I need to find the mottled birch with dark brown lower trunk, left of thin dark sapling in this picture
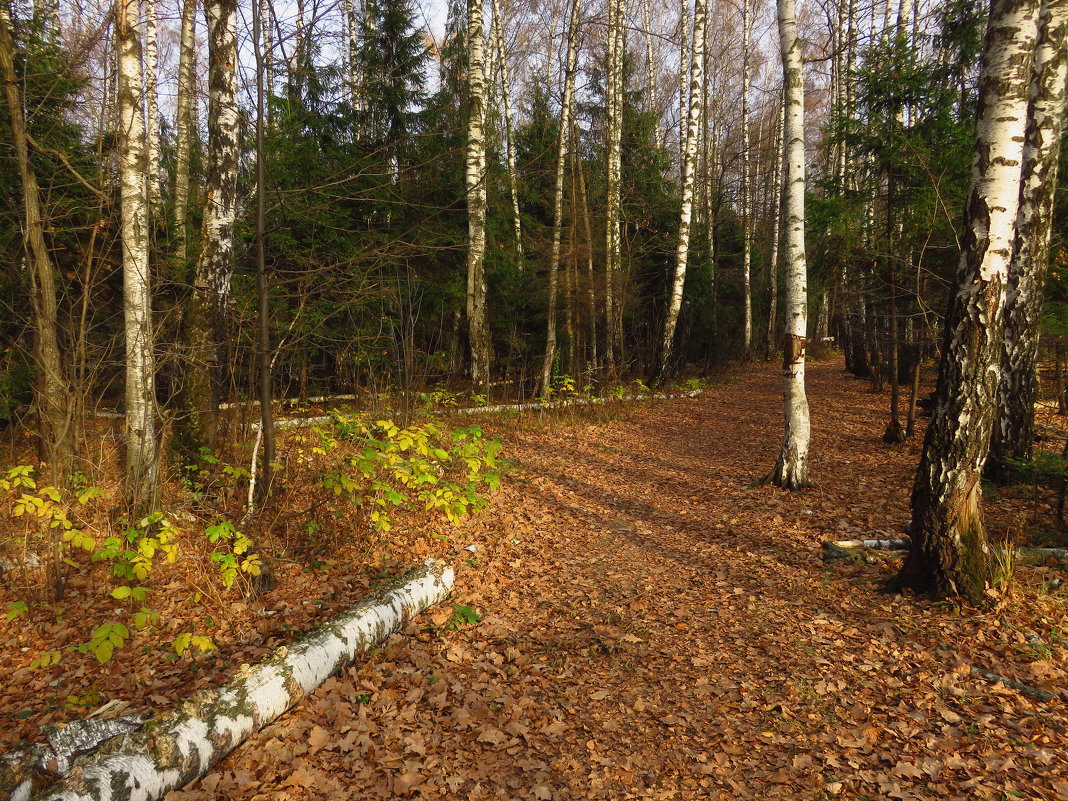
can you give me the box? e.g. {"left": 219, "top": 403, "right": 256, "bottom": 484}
{"left": 185, "top": 0, "right": 239, "bottom": 451}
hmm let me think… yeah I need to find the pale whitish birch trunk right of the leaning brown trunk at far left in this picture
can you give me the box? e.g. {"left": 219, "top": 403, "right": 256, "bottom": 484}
{"left": 115, "top": 0, "right": 159, "bottom": 521}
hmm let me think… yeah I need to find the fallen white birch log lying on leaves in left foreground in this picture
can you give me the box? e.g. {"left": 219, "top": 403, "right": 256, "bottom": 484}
{"left": 12, "top": 561, "right": 453, "bottom": 801}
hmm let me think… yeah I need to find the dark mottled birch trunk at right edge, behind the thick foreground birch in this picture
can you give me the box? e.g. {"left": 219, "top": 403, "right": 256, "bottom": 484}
{"left": 990, "top": 0, "right": 1068, "bottom": 476}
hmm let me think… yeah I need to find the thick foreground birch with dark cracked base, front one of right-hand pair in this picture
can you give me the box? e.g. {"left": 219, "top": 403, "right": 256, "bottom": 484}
{"left": 893, "top": 0, "right": 1038, "bottom": 602}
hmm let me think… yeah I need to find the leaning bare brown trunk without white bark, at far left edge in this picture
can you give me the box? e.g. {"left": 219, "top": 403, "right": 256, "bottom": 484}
{"left": 0, "top": 0, "right": 75, "bottom": 482}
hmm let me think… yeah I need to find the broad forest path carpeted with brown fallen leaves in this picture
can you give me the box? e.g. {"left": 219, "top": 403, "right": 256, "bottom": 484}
{"left": 170, "top": 363, "right": 1068, "bottom": 801}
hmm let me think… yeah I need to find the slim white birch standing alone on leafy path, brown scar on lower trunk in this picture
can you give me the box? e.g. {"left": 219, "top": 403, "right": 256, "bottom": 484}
{"left": 771, "top": 0, "right": 812, "bottom": 489}
